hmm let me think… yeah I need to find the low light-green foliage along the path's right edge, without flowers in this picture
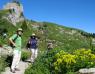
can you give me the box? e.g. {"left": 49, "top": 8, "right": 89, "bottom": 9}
{"left": 25, "top": 54, "right": 50, "bottom": 74}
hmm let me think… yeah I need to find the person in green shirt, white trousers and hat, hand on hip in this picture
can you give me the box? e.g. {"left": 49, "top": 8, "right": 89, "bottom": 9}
{"left": 9, "top": 28, "right": 23, "bottom": 73}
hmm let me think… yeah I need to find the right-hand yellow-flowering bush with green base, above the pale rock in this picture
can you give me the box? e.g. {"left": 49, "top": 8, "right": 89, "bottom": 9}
{"left": 74, "top": 49, "right": 95, "bottom": 70}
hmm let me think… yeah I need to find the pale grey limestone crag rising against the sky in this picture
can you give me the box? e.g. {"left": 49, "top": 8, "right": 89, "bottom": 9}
{"left": 3, "top": 2, "right": 24, "bottom": 26}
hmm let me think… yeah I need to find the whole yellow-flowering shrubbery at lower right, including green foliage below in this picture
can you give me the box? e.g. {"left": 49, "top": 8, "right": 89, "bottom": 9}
{"left": 53, "top": 49, "right": 95, "bottom": 74}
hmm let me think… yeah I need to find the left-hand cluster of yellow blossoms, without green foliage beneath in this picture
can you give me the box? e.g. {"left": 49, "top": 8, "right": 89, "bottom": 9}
{"left": 54, "top": 50, "right": 76, "bottom": 70}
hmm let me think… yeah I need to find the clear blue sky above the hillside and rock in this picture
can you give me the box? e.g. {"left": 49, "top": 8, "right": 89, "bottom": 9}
{"left": 0, "top": 0, "right": 95, "bottom": 33}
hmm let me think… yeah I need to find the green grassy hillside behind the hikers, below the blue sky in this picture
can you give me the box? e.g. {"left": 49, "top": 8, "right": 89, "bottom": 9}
{"left": 0, "top": 9, "right": 94, "bottom": 50}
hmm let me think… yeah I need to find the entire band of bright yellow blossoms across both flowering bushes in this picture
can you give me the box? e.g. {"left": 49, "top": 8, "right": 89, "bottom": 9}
{"left": 54, "top": 48, "right": 95, "bottom": 70}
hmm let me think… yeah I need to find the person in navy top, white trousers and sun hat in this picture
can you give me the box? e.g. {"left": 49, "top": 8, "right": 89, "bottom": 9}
{"left": 29, "top": 34, "right": 38, "bottom": 63}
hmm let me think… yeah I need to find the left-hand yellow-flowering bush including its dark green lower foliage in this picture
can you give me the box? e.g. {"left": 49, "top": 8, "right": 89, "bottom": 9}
{"left": 53, "top": 50, "right": 76, "bottom": 74}
